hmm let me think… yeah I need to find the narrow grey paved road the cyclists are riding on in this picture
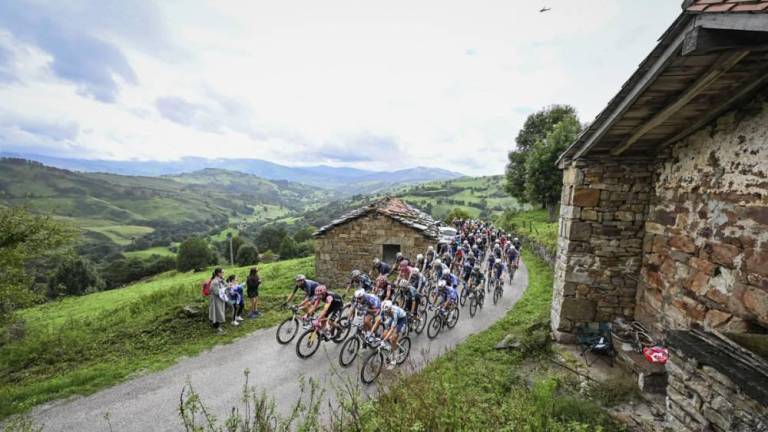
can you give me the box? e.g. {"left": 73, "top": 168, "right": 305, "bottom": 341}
{"left": 32, "top": 263, "right": 528, "bottom": 432}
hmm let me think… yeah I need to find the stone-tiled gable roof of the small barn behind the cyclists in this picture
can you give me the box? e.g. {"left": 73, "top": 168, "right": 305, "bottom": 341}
{"left": 314, "top": 198, "right": 439, "bottom": 239}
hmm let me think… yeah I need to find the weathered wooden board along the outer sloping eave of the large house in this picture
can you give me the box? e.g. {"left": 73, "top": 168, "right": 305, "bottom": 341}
{"left": 558, "top": 16, "right": 694, "bottom": 163}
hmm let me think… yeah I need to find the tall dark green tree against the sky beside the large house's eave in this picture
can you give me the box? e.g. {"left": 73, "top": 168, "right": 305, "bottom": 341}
{"left": 504, "top": 105, "right": 581, "bottom": 221}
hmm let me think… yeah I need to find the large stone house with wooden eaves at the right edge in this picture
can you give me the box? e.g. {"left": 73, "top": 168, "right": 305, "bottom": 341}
{"left": 552, "top": 0, "right": 768, "bottom": 431}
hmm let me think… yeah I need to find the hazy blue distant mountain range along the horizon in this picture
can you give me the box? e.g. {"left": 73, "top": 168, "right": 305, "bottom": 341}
{"left": 0, "top": 153, "right": 462, "bottom": 195}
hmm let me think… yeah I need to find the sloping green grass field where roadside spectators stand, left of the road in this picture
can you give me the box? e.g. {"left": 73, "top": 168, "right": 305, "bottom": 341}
{"left": 0, "top": 257, "right": 314, "bottom": 419}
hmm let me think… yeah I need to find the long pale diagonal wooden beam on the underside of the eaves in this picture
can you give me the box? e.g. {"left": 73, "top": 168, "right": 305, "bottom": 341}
{"left": 611, "top": 50, "right": 749, "bottom": 156}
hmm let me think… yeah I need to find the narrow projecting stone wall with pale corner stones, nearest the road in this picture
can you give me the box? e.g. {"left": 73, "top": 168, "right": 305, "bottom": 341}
{"left": 552, "top": 158, "right": 652, "bottom": 340}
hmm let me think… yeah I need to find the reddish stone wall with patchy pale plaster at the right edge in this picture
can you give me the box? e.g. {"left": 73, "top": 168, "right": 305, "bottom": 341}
{"left": 637, "top": 98, "right": 768, "bottom": 332}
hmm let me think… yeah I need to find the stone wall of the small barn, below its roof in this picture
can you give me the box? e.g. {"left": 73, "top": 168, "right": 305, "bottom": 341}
{"left": 315, "top": 213, "right": 436, "bottom": 289}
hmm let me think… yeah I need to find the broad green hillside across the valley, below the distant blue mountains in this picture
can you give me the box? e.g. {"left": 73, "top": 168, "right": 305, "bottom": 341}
{"left": 0, "top": 159, "right": 333, "bottom": 256}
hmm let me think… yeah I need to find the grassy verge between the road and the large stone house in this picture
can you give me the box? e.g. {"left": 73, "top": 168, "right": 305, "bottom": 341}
{"left": 362, "top": 250, "right": 621, "bottom": 432}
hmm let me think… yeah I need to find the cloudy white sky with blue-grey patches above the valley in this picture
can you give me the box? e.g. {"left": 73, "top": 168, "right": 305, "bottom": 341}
{"left": 0, "top": 0, "right": 681, "bottom": 175}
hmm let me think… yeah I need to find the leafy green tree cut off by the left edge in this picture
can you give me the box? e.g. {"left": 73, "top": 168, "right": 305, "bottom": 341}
{"left": 0, "top": 207, "right": 76, "bottom": 322}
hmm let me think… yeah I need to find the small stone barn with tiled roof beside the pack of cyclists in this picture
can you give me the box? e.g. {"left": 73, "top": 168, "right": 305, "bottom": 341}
{"left": 315, "top": 198, "right": 439, "bottom": 288}
